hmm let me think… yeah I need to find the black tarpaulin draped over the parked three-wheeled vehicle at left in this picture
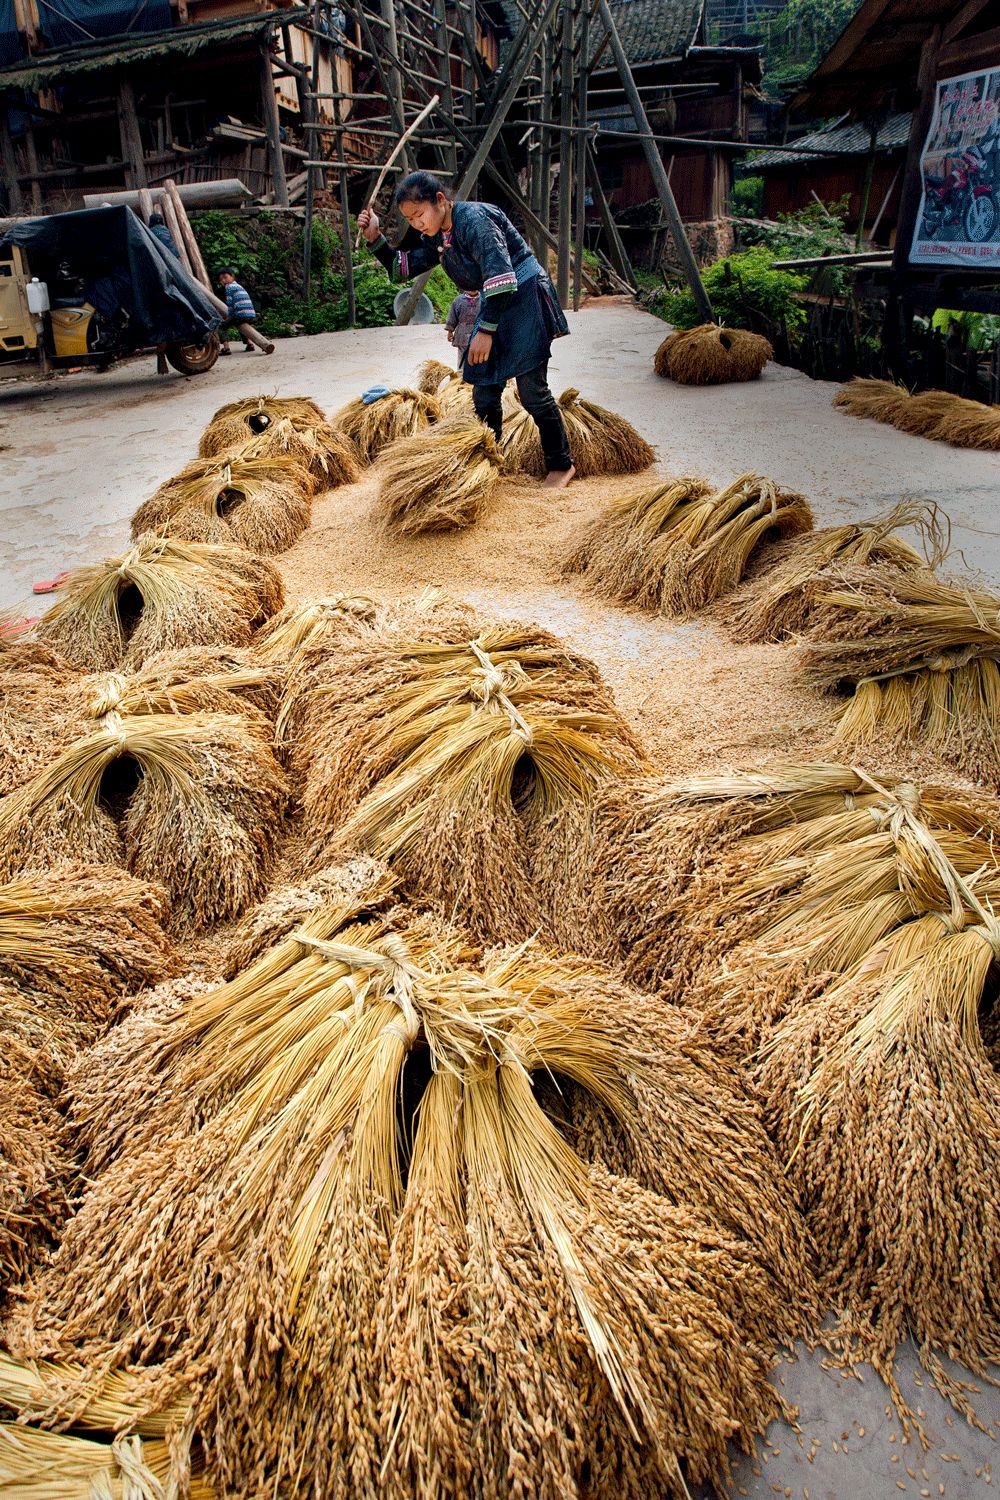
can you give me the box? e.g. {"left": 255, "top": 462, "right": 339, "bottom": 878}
{"left": 0, "top": 207, "right": 222, "bottom": 348}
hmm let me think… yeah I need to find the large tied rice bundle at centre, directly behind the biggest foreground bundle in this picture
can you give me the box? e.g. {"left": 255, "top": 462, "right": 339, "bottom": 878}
{"left": 293, "top": 626, "right": 640, "bottom": 941}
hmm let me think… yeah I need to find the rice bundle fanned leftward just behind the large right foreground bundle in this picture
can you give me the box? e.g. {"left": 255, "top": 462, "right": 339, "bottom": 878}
{"left": 589, "top": 764, "right": 997, "bottom": 1008}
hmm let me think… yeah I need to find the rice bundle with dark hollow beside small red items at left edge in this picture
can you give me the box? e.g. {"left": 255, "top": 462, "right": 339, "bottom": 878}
{"left": 37, "top": 536, "right": 285, "bottom": 672}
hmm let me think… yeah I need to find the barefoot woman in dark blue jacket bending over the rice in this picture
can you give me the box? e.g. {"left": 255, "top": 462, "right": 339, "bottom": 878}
{"left": 358, "top": 173, "right": 576, "bottom": 489}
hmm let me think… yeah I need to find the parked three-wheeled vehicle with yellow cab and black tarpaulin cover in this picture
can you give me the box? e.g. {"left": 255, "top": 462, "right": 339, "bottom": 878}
{"left": 0, "top": 206, "right": 222, "bottom": 375}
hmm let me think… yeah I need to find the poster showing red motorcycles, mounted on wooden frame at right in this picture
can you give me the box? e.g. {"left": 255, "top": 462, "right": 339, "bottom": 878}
{"left": 910, "top": 68, "right": 1000, "bottom": 270}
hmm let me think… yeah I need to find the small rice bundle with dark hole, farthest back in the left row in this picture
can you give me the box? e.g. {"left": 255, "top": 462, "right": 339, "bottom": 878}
{"left": 198, "top": 396, "right": 361, "bottom": 489}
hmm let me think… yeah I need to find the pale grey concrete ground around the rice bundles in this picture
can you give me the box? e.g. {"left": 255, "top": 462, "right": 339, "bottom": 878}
{"left": 0, "top": 299, "right": 1000, "bottom": 1500}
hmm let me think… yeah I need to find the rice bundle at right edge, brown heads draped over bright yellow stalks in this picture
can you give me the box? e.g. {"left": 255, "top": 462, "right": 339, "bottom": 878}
{"left": 796, "top": 567, "right": 1000, "bottom": 782}
